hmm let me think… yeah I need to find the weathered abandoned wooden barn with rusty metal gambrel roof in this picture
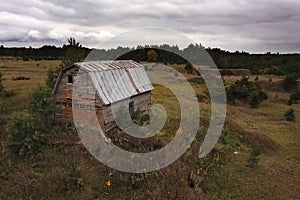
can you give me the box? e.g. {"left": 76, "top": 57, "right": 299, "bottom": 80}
{"left": 53, "top": 60, "right": 153, "bottom": 131}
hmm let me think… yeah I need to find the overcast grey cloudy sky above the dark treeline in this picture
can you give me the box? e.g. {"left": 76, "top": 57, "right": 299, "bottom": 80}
{"left": 0, "top": 0, "right": 300, "bottom": 52}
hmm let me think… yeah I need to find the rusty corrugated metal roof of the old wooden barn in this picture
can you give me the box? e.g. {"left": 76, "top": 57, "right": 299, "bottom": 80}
{"left": 74, "top": 60, "right": 153, "bottom": 105}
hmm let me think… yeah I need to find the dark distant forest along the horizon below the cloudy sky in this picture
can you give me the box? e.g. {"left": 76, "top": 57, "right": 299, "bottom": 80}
{"left": 0, "top": 44, "right": 300, "bottom": 75}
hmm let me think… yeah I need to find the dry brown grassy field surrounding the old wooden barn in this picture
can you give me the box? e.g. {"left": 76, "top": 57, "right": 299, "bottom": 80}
{"left": 0, "top": 60, "right": 300, "bottom": 199}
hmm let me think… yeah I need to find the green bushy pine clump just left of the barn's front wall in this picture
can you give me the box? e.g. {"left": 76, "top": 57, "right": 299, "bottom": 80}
{"left": 7, "top": 84, "right": 54, "bottom": 156}
